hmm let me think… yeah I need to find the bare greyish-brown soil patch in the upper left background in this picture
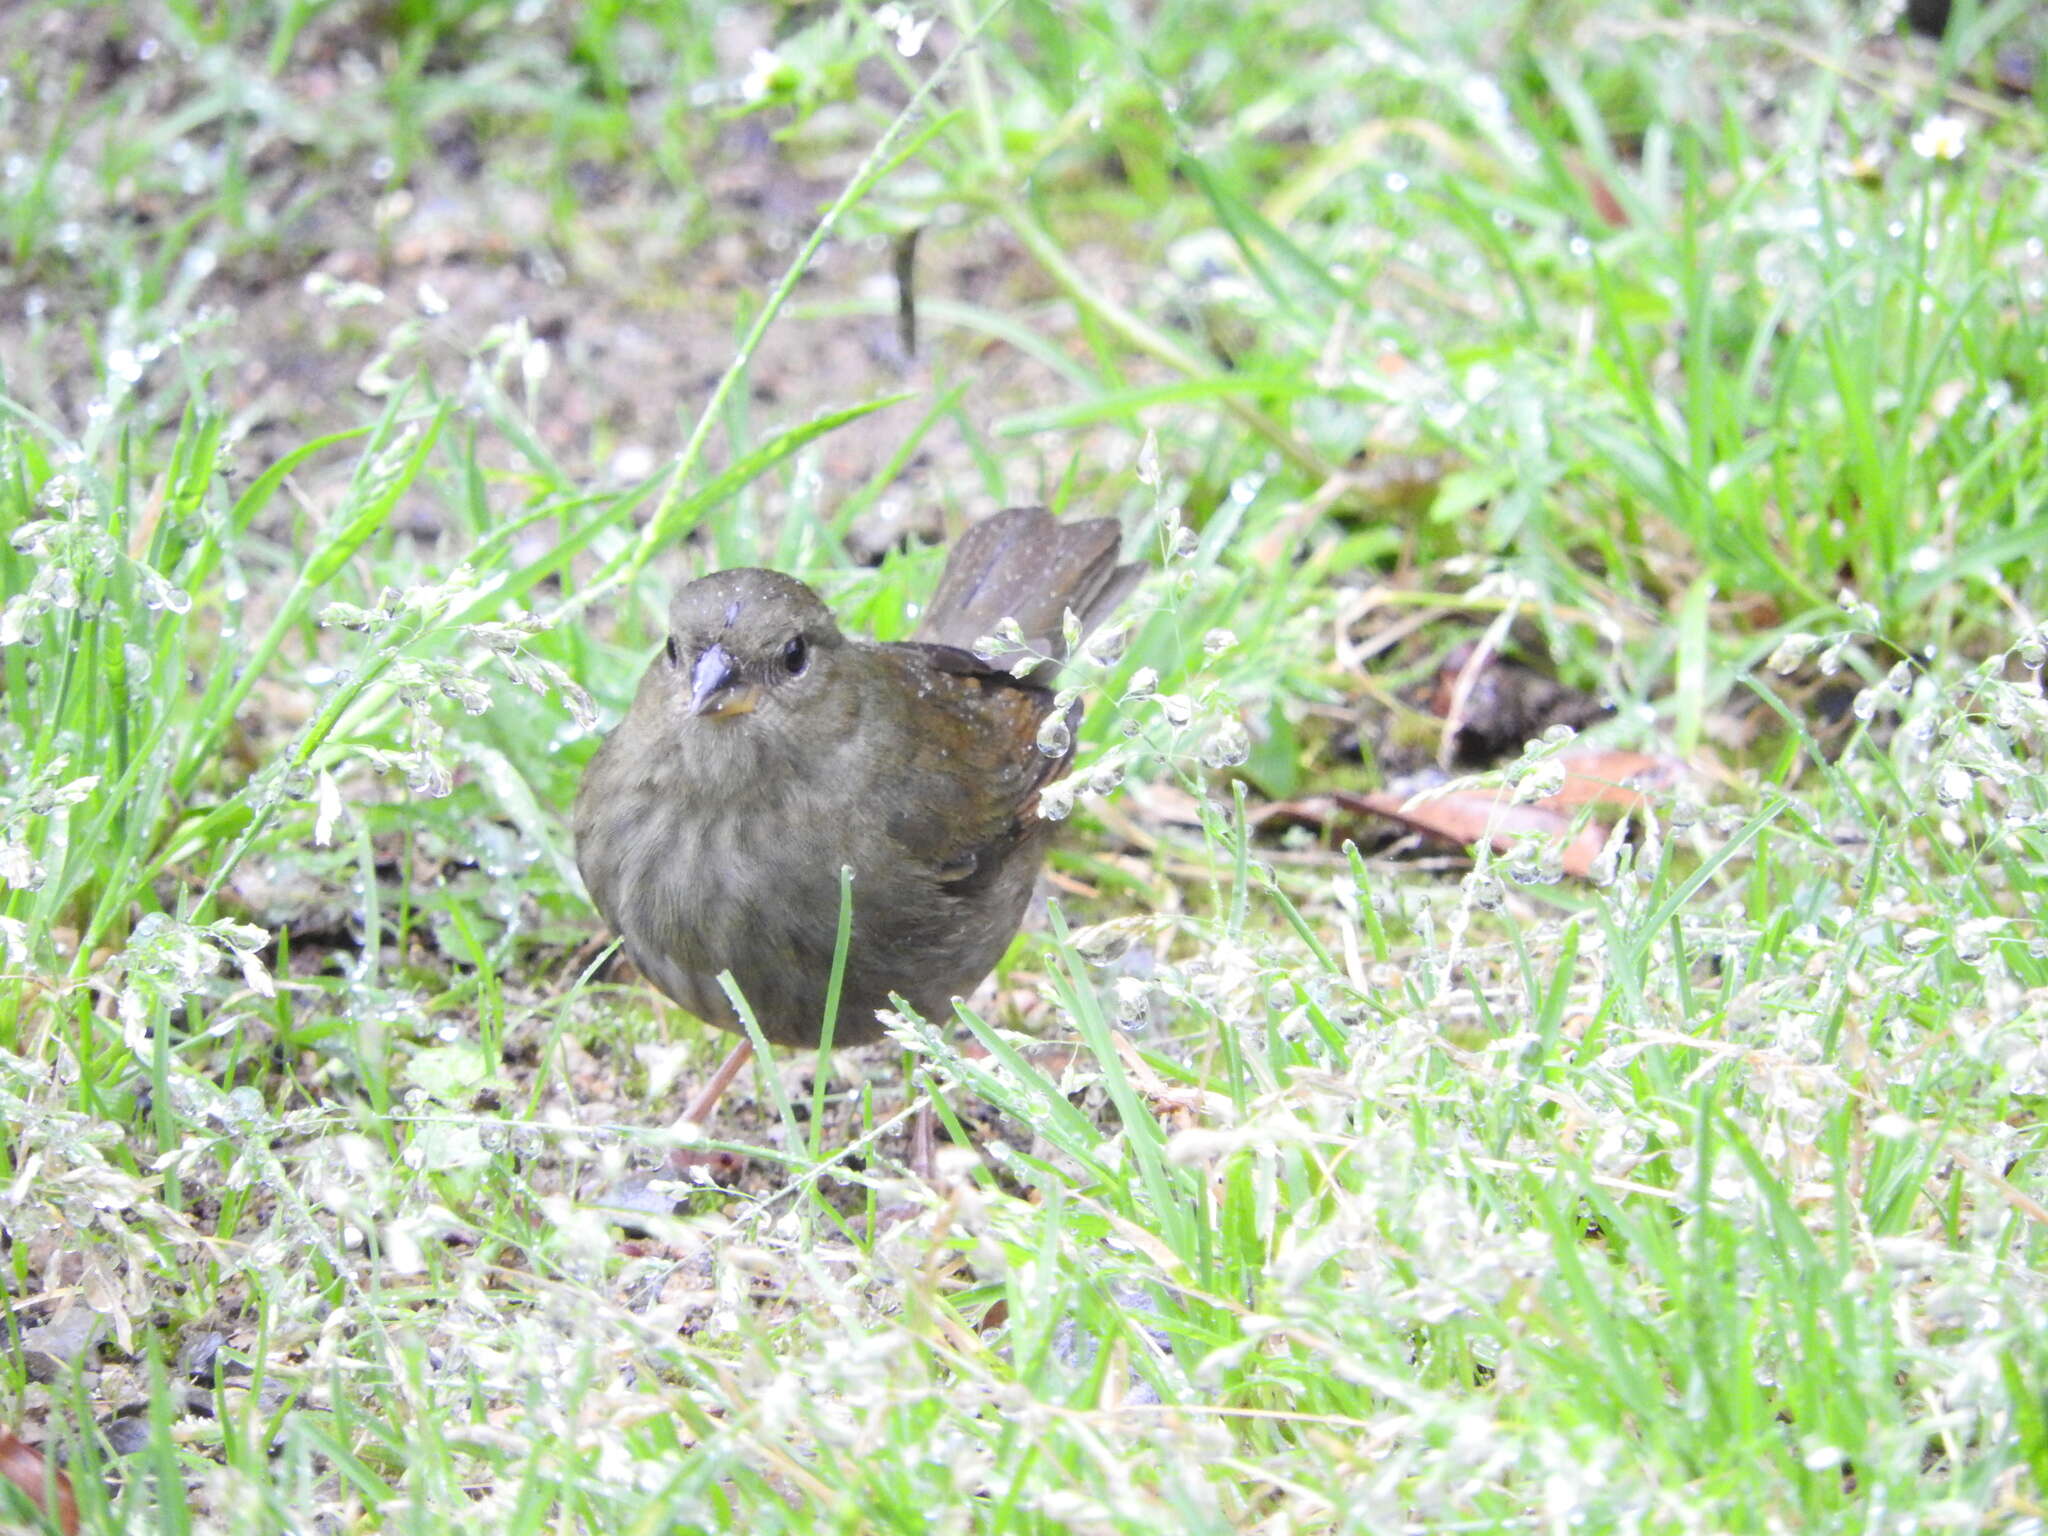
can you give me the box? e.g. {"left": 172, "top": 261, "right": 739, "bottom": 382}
{"left": 0, "top": 8, "right": 1122, "bottom": 553}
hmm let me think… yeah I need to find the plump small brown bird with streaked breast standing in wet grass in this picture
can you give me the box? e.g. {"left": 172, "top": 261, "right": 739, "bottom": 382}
{"left": 575, "top": 508, "right": 1143, "bottom": 1163}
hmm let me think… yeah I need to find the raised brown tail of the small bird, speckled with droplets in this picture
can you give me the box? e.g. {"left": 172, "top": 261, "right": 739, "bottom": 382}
{"left": 918, "top": 506, "right": 1145, "bottom": 682}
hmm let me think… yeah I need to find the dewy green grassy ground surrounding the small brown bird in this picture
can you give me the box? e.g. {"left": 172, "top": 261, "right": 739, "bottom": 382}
{"left": 0, "top": 0, "right": 2048, "bottom": 1532}
